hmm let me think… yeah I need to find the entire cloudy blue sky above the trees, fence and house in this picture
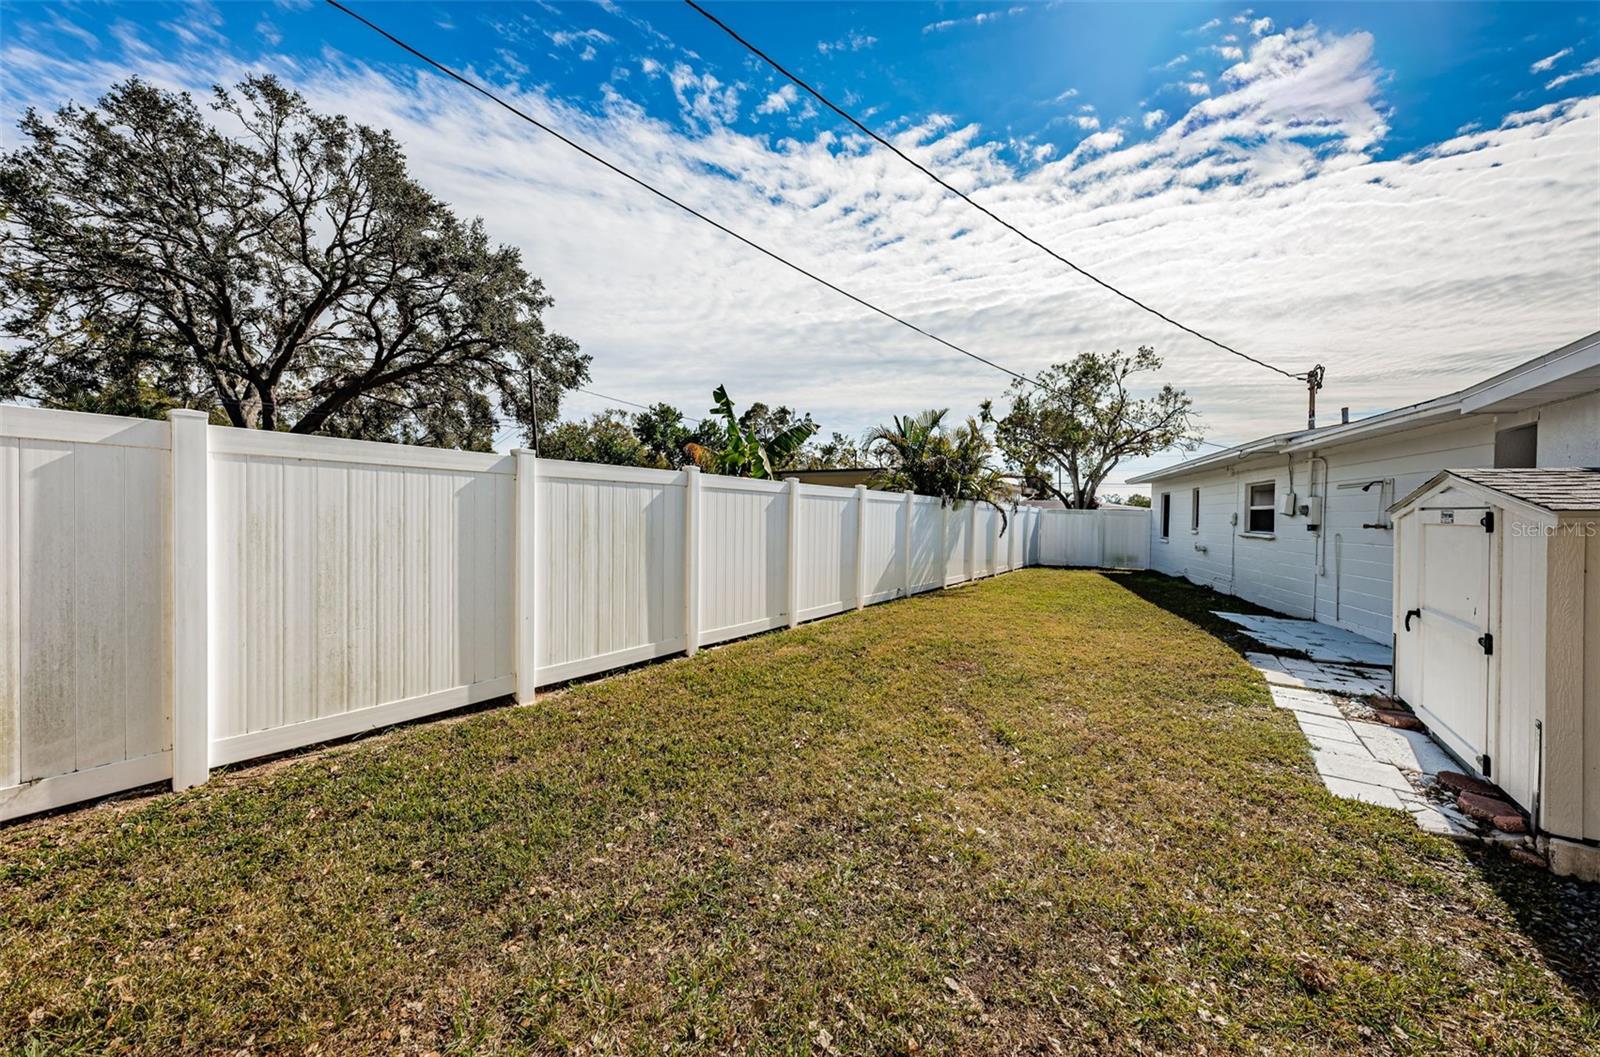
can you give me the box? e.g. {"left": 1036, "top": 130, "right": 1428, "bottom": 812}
{"left": 0, "top": 0, "right": 1600, "bottom": 473}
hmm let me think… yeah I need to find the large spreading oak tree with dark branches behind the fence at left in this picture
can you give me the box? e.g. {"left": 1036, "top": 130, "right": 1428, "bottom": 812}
{"left": 0, "top": 77, "right": 589, "bottom": 449}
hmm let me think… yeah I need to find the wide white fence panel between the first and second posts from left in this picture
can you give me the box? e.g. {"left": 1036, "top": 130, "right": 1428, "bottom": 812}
{"left": 210, "top": 427, "right": 514, "bottom": 766}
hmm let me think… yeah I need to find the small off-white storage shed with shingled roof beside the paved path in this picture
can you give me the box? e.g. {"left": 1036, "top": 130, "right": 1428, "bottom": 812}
{"left": 1390, "top": 469, "right": 1600, "bottom": 880}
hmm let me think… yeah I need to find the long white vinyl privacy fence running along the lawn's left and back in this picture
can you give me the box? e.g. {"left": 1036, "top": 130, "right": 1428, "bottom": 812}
{"left": 0, "top": 406, "right": 1149, "bottom": 819}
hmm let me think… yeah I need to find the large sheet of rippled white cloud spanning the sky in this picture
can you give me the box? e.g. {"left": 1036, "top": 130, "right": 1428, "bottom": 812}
{"left": 0, "top": 16, "right": 1600, "bottom": 473}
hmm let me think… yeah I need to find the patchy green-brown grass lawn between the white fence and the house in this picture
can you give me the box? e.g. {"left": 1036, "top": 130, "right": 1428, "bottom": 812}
{"left": 0, "top": 569, "right": 1600, "bottom": 1057}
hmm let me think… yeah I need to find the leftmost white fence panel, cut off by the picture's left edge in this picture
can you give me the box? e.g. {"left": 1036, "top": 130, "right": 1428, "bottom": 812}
{"left": 0, "top": 408, "right": 173, "bottom": 817}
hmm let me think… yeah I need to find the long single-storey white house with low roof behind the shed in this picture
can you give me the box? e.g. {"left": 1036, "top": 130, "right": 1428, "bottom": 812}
{"left": 1130, "top": 333, "right": 1600, "bottom": 643}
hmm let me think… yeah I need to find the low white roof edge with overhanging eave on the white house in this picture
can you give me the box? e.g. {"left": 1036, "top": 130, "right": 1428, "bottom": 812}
{"left": 1128, "top": 331, "right": 1600, "bottom": 485}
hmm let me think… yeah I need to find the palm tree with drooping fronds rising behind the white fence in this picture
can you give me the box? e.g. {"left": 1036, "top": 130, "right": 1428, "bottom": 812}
{"left": 867, "top": 408, "right": 1011, "bottom": 536}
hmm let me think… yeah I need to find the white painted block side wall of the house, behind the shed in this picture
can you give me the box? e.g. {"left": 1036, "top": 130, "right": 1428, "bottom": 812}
{"left": 1150, "top": 416, "right": 1515, "bottom": 641}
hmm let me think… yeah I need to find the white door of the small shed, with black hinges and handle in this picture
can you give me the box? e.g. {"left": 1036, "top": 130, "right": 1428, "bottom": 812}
{"left": 1411, "top": 507, "right": 1494, "bottom": 772}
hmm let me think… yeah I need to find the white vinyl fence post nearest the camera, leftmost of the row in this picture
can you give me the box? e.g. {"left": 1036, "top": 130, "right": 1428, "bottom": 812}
{"left": 166, "top": 411, "right": 211, "bottom": 790}
